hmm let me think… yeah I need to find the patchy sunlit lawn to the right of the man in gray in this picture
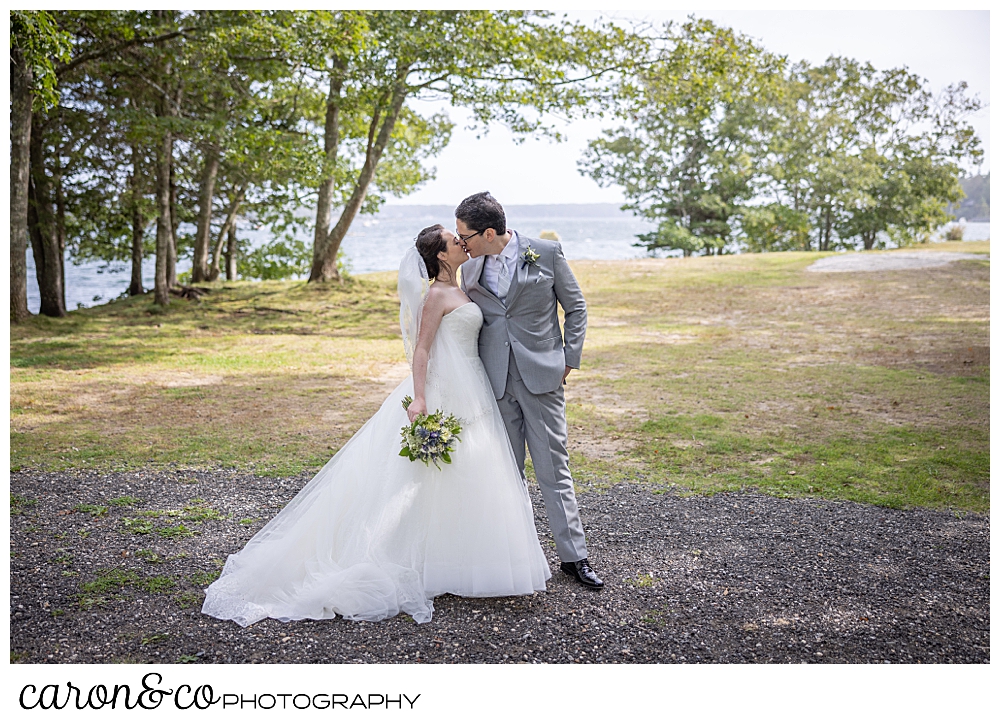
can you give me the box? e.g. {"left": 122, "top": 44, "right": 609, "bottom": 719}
{"left": 567, "top": 246, "right": 989, "bottom": 512}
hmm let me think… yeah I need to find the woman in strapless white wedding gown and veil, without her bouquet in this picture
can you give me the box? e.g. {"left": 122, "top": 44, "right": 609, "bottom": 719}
{"left": 202, "top": 224, "right": 551, "bottom": 626}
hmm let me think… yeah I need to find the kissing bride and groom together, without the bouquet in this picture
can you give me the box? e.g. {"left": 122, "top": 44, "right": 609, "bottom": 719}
{"left": 202, "top": 192, "right": 604, "bottom": 626}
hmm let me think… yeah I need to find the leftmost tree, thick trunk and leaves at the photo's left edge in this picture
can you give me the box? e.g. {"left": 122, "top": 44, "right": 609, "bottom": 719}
{"left": 10, "top": 10, "right": 69, "bottom": 322}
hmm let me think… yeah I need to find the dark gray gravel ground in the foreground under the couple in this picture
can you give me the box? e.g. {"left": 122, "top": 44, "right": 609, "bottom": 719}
{"left": 10, "top": 471, "right": 990, "bottom": 663}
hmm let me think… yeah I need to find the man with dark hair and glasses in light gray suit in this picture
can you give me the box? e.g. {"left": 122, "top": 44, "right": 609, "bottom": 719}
{"left": 455, "top": 192, "right": 604, "bottom": 589}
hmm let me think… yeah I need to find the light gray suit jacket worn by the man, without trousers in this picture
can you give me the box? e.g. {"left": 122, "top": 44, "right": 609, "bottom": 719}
{"left": 462, "top": 234, "right": 587, "bottom": 400}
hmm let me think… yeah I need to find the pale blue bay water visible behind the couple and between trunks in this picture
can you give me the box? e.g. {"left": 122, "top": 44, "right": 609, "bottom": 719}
{"left": 28, "top": 204, "right": 990, "bottom": 313}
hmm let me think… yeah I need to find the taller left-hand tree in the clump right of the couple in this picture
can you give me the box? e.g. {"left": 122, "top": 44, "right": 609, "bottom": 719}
{"left": 580, "top": 20, "right": 783, "bottom": 256}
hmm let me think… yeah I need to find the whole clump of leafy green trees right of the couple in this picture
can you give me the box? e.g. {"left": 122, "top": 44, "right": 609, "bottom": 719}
{"left": 580, "top": 19, "right": 982, "bottom": 255}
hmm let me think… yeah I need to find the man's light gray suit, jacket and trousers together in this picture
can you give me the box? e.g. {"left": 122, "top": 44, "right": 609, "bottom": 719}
{"left": 462, "top": 234, "right": 587, "bottom": 562}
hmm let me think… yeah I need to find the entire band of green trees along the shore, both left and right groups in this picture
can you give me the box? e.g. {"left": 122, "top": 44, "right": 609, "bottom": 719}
{"left": 10, "top": 10, "right": 982, "bottom": 320}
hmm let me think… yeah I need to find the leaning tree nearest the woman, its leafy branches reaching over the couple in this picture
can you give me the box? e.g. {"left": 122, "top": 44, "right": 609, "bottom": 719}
{"left": 302, "top": 11, "right": 629, "bottom": 281}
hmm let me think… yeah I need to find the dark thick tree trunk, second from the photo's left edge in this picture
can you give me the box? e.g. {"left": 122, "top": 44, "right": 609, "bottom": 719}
{"left": 28, "top": 114, "right": 66, "bottom": 317}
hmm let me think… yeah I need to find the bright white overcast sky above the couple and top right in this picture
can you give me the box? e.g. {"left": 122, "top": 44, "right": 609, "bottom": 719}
{"left": 393, "top": 8, "right": 990, "bottom": 204}
